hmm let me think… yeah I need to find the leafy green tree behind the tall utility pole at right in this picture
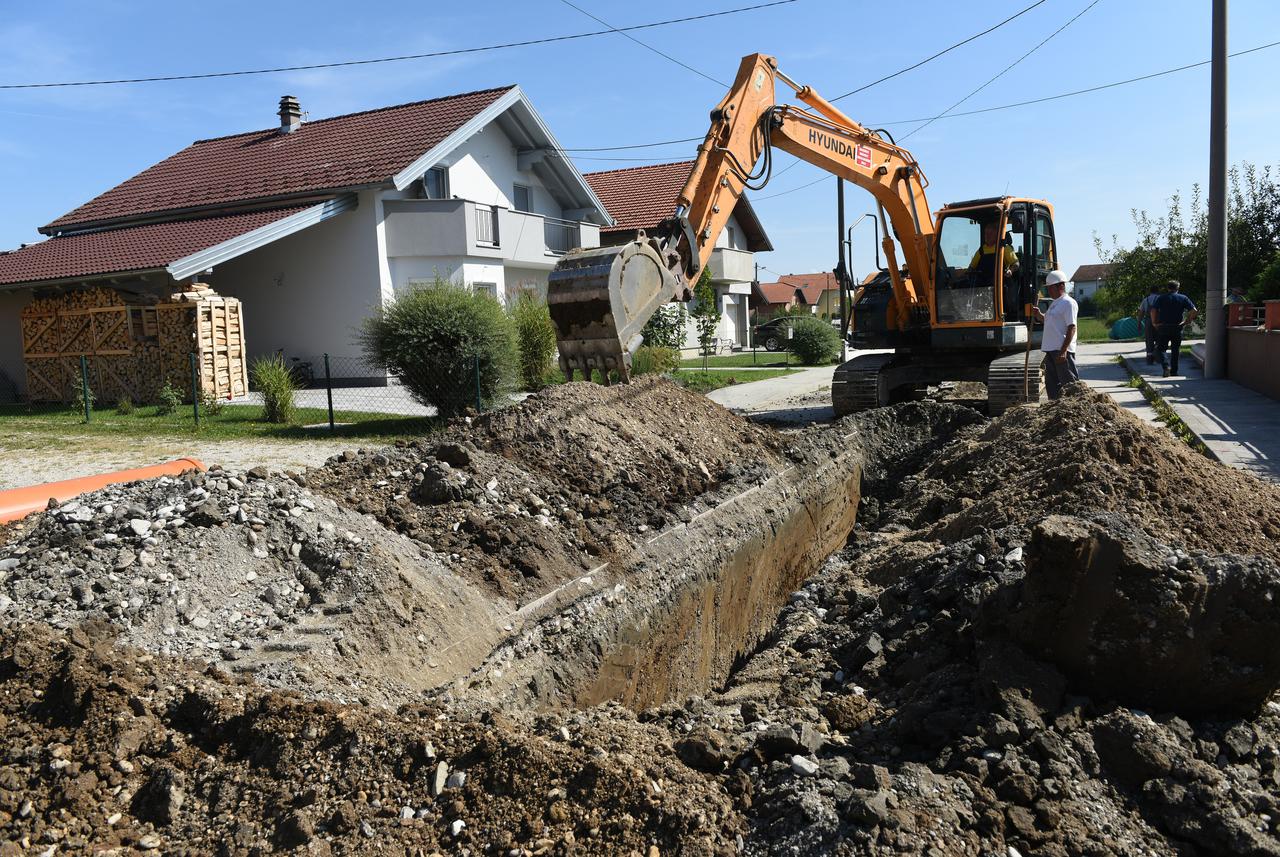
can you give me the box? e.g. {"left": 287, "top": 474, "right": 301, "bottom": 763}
{"left": 1093, "top": 162, "right": 1280, "bottom": 320}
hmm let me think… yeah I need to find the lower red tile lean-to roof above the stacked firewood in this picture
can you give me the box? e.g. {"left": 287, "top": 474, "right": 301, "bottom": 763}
{"left": 0, "top": 206, "right": 308, "bottom": 285}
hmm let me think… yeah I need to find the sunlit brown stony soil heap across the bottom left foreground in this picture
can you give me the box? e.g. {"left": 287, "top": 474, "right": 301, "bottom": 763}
{"left": 0, "top": 625, "right": 742, "bottom": 854}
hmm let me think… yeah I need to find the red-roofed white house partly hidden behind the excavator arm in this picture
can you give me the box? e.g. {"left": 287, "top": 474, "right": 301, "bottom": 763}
{"left": 585, "top": 161, "right": 773, "bottom": 348}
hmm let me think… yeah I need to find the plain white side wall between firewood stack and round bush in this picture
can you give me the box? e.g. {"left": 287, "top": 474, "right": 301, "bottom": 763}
{"left": 209, "top": 192, "right": 385, "bottom": 358}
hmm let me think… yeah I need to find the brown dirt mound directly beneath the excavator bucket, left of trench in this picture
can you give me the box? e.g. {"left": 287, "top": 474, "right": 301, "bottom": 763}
{"left": 307, "top": 379, "right": 786, "bottom": 599}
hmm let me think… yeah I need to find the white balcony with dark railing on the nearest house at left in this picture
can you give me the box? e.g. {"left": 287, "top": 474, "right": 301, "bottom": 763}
{"left": 383, "top": 200, "right": 599, "bottom": 269}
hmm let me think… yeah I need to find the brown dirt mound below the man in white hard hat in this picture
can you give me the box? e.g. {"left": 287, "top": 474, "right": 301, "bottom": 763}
{"left": 883, "top": 385, "right": 1280, "bottom": 562}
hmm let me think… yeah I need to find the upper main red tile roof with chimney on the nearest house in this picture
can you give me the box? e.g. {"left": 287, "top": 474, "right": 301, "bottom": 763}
{"left": 44, "top": 86, "right": 515, "bottom": 230}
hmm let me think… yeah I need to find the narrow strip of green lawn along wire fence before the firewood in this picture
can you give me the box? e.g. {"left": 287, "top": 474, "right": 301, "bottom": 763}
{"left": 0, "top": 404, "right": 436, "bottom": 440}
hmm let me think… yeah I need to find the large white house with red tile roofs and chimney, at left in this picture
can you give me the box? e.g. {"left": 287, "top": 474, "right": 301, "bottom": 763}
{"left": 0, "top": 86, "right": 612, "bottom": 391}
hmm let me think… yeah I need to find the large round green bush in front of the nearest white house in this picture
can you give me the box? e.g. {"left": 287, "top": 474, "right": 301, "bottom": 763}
{"left": 360, "top": 278, "right": 517, "bottom": 417}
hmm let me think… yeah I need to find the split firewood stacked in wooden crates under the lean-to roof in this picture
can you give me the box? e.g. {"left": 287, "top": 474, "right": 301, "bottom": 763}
{"left": 22, "top": 283, "right": 248, "bottom": 404}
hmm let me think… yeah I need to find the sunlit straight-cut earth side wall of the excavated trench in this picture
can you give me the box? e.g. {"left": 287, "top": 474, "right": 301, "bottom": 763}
{"left": 456, "top": 429, "right": 863, "bottom": 710}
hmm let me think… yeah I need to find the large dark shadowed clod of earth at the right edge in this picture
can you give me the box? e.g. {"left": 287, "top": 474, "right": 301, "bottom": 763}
{"left": 998, "top": 515, "right": 1280, "bottom": 716}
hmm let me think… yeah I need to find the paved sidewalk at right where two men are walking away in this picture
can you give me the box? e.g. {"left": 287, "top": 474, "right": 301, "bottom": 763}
{"left": 1078, "top": 343, "right": 1280, "bottom": 481}
